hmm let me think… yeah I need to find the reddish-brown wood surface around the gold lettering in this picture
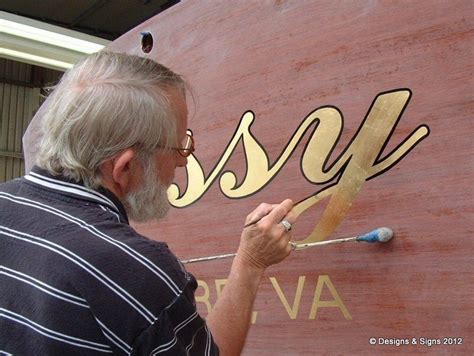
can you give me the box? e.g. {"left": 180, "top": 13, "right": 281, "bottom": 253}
{"left": 110, "top": 0, "right": 474, "bottom": 355}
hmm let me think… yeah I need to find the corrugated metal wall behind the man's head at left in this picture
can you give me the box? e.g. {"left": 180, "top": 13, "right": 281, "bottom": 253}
{"left": 0, "top": 58, "right": 62, "bottom": 182}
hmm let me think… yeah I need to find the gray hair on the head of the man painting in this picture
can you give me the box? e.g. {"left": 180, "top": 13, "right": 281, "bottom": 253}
{"left": 37, "top": 52, "right": 185, "bottom": 188}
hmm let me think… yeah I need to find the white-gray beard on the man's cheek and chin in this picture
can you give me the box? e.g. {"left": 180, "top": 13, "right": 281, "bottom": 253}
{"left": 124, "top": 162, "right": 170, "bottom": 222}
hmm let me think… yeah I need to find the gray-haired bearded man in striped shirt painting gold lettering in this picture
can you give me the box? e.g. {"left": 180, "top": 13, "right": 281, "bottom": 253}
{"left": 0, "top": 52, "right": 295, "bottom": 355}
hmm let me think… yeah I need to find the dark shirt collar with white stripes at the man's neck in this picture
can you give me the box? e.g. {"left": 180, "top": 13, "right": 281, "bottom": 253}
{"left": 24, "top": 166, "right": 128, "bottom": 224}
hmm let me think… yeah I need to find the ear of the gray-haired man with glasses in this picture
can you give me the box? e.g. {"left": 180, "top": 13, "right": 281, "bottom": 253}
{"left": 101, "top": 148, "right": 140, "bottom": 199}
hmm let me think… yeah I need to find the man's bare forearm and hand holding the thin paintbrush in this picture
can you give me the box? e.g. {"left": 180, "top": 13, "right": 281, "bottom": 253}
{"left": 207, "top": 199, "right": 296, "bottom": 356}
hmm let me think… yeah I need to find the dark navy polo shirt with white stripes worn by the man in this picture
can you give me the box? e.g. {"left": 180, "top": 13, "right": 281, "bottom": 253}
{"left": 0, "top": 167, "right": 219, "bottom": 355}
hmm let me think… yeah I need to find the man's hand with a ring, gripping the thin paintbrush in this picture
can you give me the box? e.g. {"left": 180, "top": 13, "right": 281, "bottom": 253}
{"left": 236, "top": 199, "right": 296, "bottom": 270}
